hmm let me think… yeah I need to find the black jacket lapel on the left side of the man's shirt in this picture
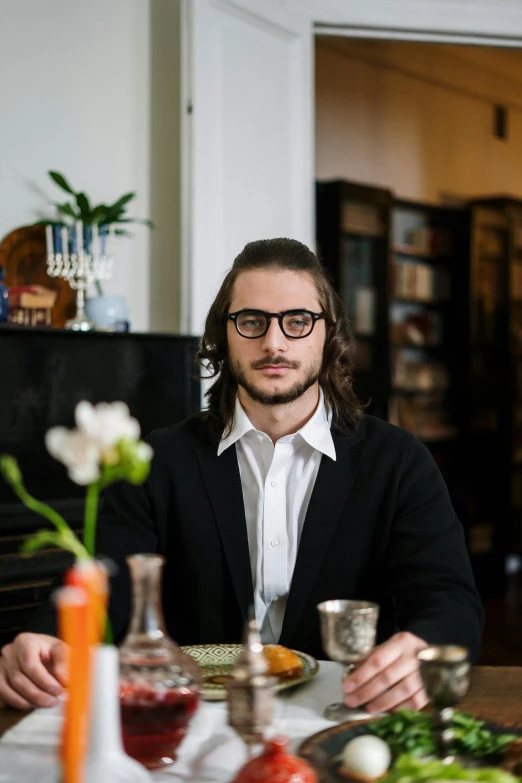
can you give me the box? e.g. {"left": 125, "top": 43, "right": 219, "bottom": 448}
{"left": 195, "top": 444, "right": 254, "bottom": 620}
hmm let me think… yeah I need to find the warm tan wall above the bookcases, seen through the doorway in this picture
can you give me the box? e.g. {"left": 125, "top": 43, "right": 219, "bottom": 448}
{"left": 316, "top": 39, "right": 522, "bottom": 203}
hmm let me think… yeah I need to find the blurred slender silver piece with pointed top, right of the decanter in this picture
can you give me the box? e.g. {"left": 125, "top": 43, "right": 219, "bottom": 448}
{"left": 227, "top": 618, "right": 275, "bottom": 746}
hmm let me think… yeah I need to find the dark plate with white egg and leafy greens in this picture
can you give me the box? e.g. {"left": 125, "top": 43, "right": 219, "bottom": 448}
{"left": 298, "top": 710, "right": 522, "bottom": 783}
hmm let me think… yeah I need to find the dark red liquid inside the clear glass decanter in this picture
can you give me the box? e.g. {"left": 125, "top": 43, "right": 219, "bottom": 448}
{"left": 120, "top": 685, "right": 199, "bottom": 769}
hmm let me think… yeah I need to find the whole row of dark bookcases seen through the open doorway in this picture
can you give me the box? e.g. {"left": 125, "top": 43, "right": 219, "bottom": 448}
{"left": 317, "top": 180, "right": 522, "bottom": 594}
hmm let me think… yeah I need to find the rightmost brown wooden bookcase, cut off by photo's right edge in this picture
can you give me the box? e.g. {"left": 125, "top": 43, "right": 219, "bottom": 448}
{"left": 469, "top": 197, "right": 522, "bottom": 586}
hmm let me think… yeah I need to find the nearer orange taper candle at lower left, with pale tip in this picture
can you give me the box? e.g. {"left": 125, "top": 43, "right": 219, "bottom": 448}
{"left": 56, "top": 587, "right": 91, "bottom": 783}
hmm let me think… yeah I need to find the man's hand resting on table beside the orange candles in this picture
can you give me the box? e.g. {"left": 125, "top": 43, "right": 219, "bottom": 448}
{"left": 0, "top": 633, "right": 69, "bottom": 710}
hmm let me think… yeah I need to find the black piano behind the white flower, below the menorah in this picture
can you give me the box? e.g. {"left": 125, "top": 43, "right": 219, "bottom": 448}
{"left": 0, "top": 326, "right": 201, "bottom": 646}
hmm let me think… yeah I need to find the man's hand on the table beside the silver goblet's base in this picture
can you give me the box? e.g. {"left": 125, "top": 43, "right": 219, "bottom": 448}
{"left": 344, "top": 631, "right": 428, "bottom": 712}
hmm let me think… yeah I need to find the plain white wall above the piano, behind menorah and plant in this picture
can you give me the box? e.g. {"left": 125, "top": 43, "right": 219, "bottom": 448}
{"left": 0, "top": 0, "right": 150, "bottom": 331}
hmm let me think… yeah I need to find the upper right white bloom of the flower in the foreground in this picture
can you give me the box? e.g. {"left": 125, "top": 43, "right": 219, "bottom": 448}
{"left": 74, "top": 401, "right": 140, "bottom": 451}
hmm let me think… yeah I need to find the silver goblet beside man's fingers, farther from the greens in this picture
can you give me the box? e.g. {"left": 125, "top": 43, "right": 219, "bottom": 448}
{"left": 317, "top": 600, "right": 379, "bottom": 722}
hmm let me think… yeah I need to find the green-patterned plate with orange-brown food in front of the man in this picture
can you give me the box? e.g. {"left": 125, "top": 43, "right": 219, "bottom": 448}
{"left": 181, "top": 644, "right": 319, "bottom": 701}
